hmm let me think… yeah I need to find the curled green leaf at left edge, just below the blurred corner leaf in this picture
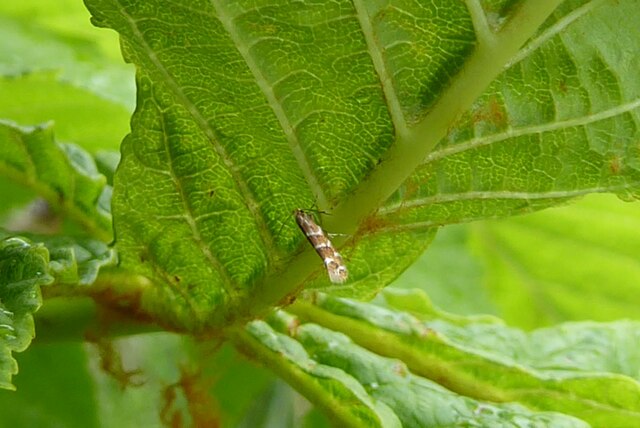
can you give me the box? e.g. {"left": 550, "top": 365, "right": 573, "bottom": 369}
{"left": 0, "top": 121, "right": 112, "bottom": 241}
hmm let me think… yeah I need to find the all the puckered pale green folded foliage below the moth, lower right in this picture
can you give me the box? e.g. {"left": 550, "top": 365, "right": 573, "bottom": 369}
{"left": 235, "top": 292, "right": 640, "bottom": 427}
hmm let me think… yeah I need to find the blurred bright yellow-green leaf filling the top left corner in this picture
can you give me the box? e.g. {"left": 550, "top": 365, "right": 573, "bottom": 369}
{"left": 0, "top": 0, "right": 134, "bottom": 109}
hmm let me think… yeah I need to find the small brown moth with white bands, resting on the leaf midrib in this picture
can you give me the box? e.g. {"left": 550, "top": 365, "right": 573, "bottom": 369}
{"left": 295, "top": 209, "right": 349, "bottom": 284}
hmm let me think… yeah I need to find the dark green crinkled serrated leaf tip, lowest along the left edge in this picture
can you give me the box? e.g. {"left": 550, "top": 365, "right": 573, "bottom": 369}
{"left": 0, "top": 238, "right": 53, "bottom": 389}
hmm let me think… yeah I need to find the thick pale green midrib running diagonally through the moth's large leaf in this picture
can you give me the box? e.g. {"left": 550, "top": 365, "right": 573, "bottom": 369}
{"left": 245, "top": 0, "right": 562, "bottom": 305}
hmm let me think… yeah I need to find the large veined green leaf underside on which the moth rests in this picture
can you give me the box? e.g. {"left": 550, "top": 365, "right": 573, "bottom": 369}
{"left": 86, "top": 0, "right": 640, "bottom": 330}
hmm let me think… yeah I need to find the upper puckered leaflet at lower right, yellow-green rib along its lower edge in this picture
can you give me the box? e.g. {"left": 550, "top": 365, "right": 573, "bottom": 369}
{"left": 293, "top": 290, "right": 640, "bottom": 427}
